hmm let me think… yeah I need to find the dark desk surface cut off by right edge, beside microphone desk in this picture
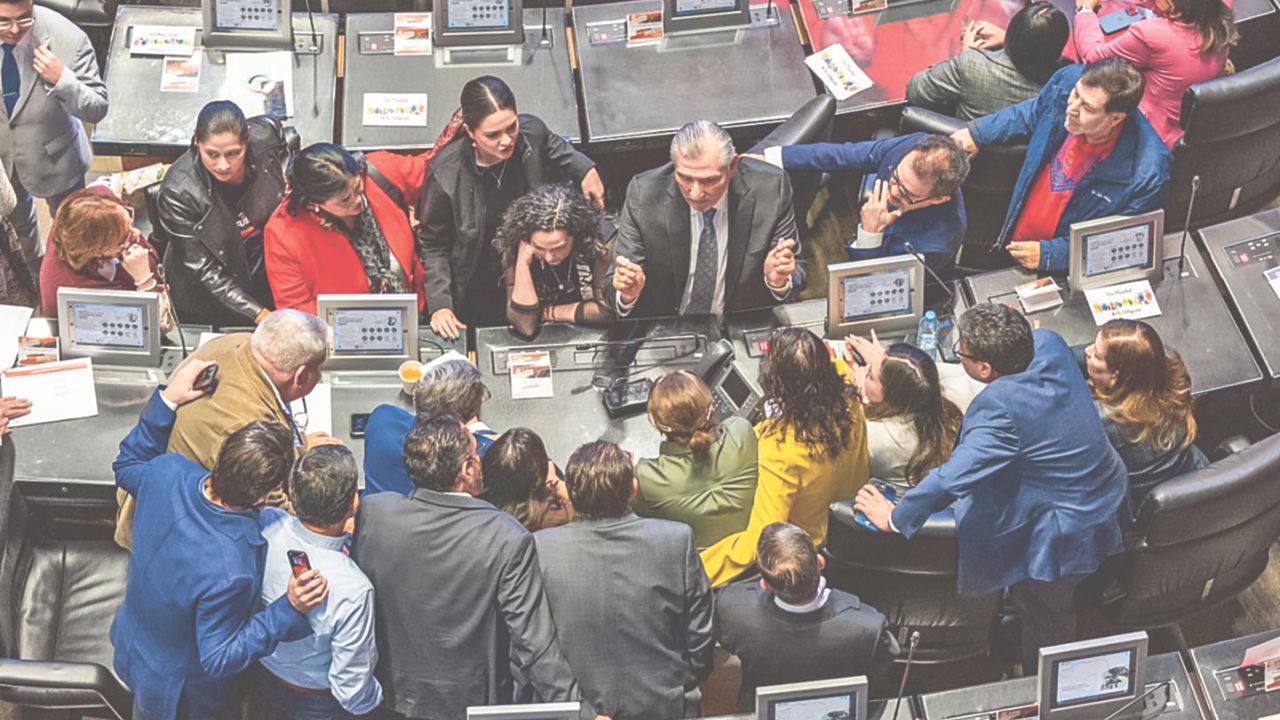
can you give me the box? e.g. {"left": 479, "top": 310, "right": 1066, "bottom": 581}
{"left": 1193, "top": 210, "right": 1280, "bottom": 380}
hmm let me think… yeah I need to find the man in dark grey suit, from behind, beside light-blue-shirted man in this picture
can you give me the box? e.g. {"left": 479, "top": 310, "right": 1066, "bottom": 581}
{"left": 353, "top": 415, "right": 594, "bottom": 720}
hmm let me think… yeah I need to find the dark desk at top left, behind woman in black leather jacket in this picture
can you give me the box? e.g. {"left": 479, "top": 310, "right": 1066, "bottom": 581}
{"left": 93, "top": 4, "right": 338, "bottom": 155}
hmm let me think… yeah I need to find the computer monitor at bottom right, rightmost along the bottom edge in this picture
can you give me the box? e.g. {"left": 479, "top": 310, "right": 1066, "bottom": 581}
{"left": 1038, "top": 633, "right": 1147, "bottom": 720}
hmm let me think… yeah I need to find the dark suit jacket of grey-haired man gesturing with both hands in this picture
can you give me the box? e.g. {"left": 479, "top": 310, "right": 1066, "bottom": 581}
{"left": 604, "top": 158, "right": 805, "bottom": 318}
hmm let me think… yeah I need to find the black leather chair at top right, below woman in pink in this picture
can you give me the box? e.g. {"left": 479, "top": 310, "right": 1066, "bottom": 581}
{"left": 1165, "top": 58, "right": 1280, "bottom": 229}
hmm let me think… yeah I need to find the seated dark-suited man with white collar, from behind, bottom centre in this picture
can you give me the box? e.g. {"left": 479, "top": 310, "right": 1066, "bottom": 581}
{"left": 716, "top": 523, "right": 900, "bottom": 712}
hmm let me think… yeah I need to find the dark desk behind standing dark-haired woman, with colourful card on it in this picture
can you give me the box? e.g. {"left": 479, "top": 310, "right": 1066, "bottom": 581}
{"left": 340, "top": 8, "right": 582, "bottom": 150}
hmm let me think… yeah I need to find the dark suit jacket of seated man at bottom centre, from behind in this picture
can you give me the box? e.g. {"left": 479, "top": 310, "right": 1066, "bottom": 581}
{"left": 716, "top": 582, "right": 901, "bottom": 712}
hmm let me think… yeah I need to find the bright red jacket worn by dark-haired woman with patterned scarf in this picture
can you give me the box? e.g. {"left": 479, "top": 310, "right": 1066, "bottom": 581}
{"left": 262, "top": 152, "right": 429, "bottom": 314}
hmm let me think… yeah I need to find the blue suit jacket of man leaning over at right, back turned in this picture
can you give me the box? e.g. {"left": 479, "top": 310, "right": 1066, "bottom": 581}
{"left": 893, "top": 331, "right": 1129, "bottom": 594}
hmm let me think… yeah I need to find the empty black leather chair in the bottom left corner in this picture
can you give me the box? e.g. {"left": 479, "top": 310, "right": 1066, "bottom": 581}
{"left": 0, "top": 437, "right": 133, "bottom": 720}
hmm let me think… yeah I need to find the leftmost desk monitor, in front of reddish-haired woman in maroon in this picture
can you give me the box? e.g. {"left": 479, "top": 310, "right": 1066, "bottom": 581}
{"left": 58, "top": 287, "right": 160, "bottom": 368}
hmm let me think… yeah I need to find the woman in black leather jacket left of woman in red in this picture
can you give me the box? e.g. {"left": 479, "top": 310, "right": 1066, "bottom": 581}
{"left": 156, "top": 100, "right": 289, "bottom": 327}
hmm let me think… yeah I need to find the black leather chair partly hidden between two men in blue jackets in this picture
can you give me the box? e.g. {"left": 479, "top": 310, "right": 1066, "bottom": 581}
{"left": 899, "top": 105, "right": 1027, "bottom": 269}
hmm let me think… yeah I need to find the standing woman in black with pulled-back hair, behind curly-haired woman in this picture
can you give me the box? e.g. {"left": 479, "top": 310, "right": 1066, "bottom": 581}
{"left": 417, "top": 76, "right": 604, "bottom": 338}
